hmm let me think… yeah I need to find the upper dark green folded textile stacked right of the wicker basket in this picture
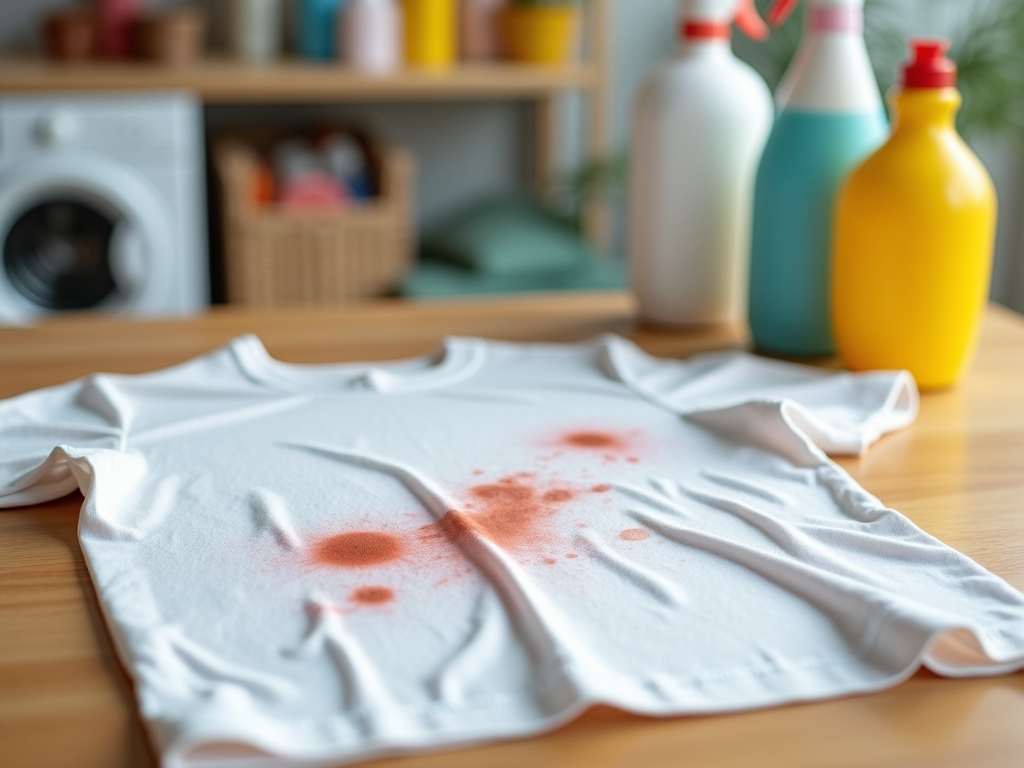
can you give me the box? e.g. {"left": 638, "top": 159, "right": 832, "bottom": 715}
{"left": 421, "top": 196, "right": 596, "bottom": 276}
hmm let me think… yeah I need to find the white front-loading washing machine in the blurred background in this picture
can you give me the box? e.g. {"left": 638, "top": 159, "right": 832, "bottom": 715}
{"left": 0, "top": 92, "right": 210, "bottom": 325}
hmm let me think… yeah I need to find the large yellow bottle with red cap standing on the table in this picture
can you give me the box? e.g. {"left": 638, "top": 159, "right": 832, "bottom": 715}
{"left": 831, "top": 40, "right": 995, "bottom": 389}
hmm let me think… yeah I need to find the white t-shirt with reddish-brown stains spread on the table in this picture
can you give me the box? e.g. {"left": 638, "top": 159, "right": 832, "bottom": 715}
{"left": 0, "top": 336, "right": 1024, "bottom": 766}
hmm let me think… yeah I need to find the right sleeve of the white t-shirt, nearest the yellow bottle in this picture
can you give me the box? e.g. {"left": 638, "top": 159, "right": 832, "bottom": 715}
{"left": 608, "top": 339, "right": 919, "bottom": 455}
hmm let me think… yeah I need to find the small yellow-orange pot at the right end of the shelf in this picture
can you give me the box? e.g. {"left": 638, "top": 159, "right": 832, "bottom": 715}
{"left": 501, "top": 3, "right": 580, "bottom": 66}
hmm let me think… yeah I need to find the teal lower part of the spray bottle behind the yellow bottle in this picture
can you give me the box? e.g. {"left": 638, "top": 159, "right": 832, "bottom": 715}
{"left": 750, "top": 110, "right": 889, "bottom": 356}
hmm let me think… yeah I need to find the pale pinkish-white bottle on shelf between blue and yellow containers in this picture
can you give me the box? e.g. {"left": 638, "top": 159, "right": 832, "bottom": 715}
{"left": 338, "top": 0, "right": 402, "bottom": 74}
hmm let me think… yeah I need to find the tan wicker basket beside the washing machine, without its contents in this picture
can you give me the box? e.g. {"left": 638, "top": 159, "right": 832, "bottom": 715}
{"left": 214, "top": 141, "right": 414, "bottom": 306}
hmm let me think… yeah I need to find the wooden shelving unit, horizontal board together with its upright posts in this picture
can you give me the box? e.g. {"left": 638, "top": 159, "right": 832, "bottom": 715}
{"left": 0, "top": 0, "right": 612, "bottom": 244}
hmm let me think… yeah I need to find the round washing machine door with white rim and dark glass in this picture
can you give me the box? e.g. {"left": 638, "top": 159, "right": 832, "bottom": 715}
{"left": 0, "top": 150, "right": 174, "bottom": 324}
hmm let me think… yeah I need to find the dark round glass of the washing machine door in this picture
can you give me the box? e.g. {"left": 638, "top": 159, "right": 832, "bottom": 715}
{"left": 3, "top": 200, "right": 118, "bottom": 310}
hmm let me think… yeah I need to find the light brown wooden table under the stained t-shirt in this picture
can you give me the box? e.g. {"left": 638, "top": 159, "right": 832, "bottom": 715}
{"left": 0, "top": 294, "right": 1024, "bottom": 768}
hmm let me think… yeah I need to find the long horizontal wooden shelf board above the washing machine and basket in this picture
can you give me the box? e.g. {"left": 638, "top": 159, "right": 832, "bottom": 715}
{"left": 0, "top": 58, "right": 598, "bottom": 103}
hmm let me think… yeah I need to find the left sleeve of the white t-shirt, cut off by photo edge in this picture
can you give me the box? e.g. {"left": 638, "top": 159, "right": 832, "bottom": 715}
{"left": 0, "top": 375, "right": 125, "bottom": 508}
